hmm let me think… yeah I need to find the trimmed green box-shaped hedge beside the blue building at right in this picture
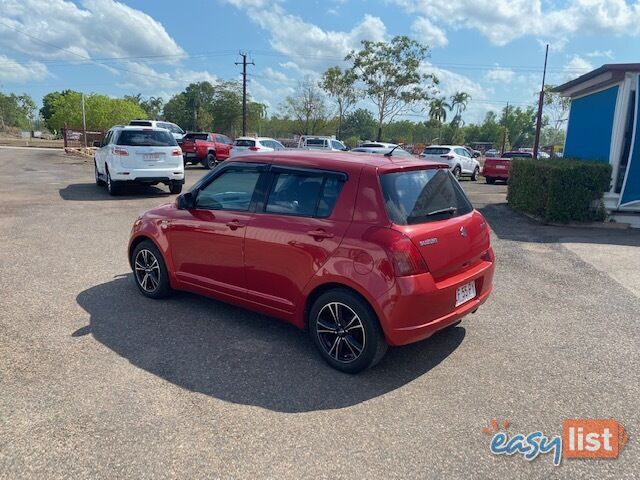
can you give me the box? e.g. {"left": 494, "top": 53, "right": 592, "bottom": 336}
{"left": 507, "top": 159, "right": 611, "bottom": 223}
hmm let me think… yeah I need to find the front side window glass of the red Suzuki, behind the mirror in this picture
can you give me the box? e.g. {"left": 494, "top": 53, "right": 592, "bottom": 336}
{"left": 196, "top": 168, "right": 260, "bottom": 212}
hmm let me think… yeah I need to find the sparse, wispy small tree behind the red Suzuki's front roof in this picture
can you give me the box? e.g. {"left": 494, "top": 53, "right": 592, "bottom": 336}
{"left": 280, "top": 77, "right": 329, "bottom": 135}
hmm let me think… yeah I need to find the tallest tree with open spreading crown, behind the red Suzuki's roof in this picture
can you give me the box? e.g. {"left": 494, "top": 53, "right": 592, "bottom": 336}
{"left": 345, "top": 36, "right": 438, "bottom": 140}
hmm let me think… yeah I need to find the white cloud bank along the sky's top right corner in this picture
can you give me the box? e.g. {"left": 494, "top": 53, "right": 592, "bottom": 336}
{"left": 391, "top": 0, "right": 640, "bottom": 45}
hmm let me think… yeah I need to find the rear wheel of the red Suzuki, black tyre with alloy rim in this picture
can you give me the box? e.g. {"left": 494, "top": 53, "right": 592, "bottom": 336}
{"left": 308, "top": 289, "right": 388, "bottom": 373}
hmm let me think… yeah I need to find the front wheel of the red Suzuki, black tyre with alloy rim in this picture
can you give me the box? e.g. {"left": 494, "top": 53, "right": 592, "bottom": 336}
{"left": 131, "top": 240, "right": 171, "bottom": 299}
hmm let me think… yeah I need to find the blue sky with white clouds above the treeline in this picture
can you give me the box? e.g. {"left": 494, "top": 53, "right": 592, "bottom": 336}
{"left": 0, "top": 0, "right": 640, "bottom": 123}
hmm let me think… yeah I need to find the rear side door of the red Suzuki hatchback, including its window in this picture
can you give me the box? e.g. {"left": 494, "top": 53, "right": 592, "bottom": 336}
{"left": 245, "top": 167, "right": 350, "bottom": 312}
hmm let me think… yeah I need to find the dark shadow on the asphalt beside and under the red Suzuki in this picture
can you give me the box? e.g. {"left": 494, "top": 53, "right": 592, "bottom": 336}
{"left": 72, "top": 274, "right": 465, "bottom": 412}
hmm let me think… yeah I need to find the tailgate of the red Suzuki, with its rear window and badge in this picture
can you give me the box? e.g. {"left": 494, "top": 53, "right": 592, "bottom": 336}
{"left": 381, "top": 169, "right": 490, "bottom": 280}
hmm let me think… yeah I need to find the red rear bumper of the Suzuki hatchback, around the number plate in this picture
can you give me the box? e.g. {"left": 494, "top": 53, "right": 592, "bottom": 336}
{"left": 377, "top": 260, "right": 494, "bottom": 346}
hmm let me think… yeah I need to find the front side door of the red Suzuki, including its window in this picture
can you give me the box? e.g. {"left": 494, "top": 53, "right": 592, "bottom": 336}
{"left": 169, "top": 165, "right": 261, "bottom": 295}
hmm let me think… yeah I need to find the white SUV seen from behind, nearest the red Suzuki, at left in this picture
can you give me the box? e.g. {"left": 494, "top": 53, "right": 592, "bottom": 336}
{"left": 94, "top": 125, "right": 184, "bottom": 195}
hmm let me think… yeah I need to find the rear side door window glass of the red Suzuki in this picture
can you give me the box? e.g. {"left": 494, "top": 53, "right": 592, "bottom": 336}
{"left": 265, "top": 172, "right": 344, "bottom": 217}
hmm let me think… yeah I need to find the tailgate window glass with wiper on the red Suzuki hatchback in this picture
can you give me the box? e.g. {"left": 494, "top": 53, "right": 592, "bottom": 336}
{"left": 380, "top": 168, "right": 473, "bottom": 225}
